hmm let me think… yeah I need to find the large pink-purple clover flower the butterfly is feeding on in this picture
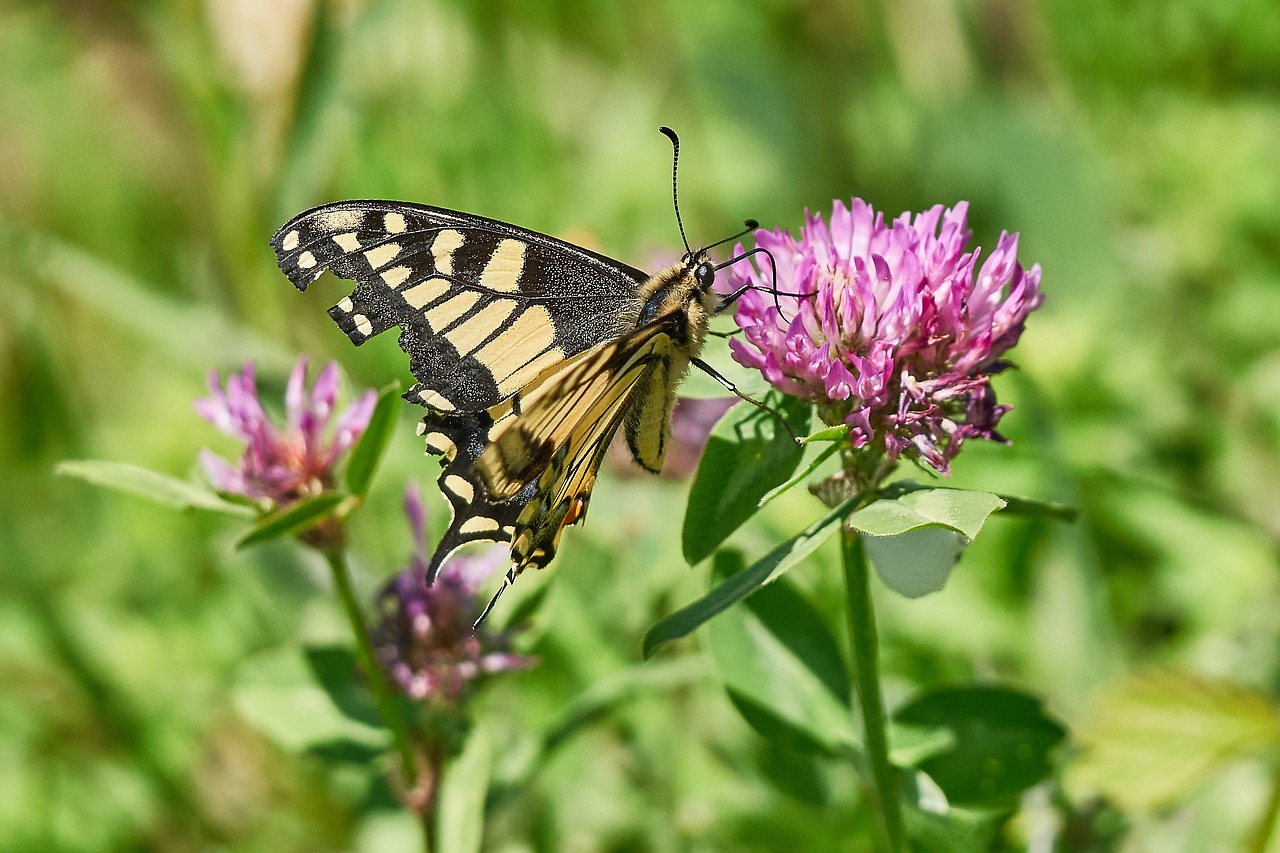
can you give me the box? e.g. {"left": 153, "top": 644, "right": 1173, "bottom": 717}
{"left": 730, "top": 199, "right": 1043, "bottom": 475}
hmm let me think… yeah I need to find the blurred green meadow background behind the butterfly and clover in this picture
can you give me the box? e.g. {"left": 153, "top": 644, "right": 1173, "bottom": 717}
{"left": 0, "top": 0, "right": 1280, "bottom": 850}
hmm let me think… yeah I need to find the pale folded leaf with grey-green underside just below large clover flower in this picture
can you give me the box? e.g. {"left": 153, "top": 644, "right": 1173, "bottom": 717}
{"left": 849, "top": 489, "right": 1005, "bottom": 598}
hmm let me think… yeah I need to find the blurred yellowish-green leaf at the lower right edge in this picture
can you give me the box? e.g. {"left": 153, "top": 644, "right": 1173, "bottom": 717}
{"left": 1066, "top": 670, "right": 1280, "bottom": 811}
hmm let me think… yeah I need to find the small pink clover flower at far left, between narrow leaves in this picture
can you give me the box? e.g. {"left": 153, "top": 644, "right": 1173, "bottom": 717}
{"left": 196, "top": 356, "right": 378, "bottom": 506}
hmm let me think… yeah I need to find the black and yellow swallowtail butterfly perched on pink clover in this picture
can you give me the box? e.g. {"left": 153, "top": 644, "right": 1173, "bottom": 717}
{"left": 271, "top": 128, "right": 756, "bottom": 619}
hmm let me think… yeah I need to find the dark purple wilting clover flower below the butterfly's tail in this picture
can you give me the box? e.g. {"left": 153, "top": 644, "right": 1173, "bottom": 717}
{"left": 374, "top": 485, "right": 538, "bottom": 704}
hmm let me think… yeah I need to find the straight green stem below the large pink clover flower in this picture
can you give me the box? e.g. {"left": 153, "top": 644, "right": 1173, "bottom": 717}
{"left": 844, "top": 526, "right": 906, "bottom": 853}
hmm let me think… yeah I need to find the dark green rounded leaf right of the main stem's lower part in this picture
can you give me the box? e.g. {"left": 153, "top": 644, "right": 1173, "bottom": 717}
{"left": 893, "top": 685, "right": 1066, "bottom": 806}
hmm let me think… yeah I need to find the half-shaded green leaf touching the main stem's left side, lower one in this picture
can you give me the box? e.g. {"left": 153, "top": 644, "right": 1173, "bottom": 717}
{"left": 708, "top": 552, "right": 859, "bottom": 754}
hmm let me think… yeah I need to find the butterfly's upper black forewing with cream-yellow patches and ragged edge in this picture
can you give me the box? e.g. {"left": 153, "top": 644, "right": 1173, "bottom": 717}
{"left": 271, "top": 201, "right": 646, "bottom": 412}
